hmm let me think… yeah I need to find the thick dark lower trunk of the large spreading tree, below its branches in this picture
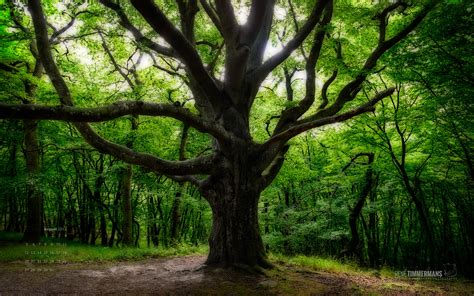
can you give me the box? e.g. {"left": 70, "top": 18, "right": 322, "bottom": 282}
{"left": 201, "top": 151, "right": 271, "bottom": 269}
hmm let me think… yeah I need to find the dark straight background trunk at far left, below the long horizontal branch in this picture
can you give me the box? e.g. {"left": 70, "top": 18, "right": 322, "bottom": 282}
{"left": 23, "top": 120, "right": 42, "bottom": 243}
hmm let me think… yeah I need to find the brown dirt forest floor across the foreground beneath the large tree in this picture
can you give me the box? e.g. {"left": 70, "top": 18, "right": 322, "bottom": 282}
{"left": 0, "top": 255, "right": 474, "bottom": 295}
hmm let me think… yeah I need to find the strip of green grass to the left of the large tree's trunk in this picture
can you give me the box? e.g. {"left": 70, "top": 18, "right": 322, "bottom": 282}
{"left": 0, "top": 233, "right": 208, "bottom": 263}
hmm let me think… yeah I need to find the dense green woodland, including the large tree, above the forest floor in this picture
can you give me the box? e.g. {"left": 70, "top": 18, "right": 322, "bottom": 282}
{"left": 0, "top": 0, "right": 474, "bottom": 276}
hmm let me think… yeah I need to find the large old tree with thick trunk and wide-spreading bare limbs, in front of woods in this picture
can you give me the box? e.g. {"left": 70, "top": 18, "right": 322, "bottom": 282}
{"left": 0, "top": 0, "right": 435, "bottom": 267}
